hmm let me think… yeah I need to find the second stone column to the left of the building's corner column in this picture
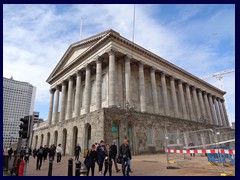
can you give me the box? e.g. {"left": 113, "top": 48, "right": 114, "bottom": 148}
{"left": 84, "top": 65, "right": 91, "bottom": 114}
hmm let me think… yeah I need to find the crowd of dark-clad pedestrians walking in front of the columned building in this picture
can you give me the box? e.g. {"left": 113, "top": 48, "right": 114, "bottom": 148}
{"left": 3, "top": 139, "right": 132, "bottom": 176}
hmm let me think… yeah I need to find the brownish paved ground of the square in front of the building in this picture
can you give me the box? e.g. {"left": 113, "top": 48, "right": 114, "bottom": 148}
{"left": 4, "top": 154, "right": 235, "bottom": 176}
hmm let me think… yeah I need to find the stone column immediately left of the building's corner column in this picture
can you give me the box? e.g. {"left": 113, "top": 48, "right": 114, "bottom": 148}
{"left": 96, "top": 57, "right": 102, "bottom": 110}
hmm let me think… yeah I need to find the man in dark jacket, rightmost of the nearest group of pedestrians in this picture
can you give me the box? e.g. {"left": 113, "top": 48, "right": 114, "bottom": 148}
{"left": 119, "top": 139, "right": 132, "bottom": 176}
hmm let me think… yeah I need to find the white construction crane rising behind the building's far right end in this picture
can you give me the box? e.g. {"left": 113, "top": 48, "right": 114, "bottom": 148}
{"left": 201, "top": 69, "right": 235, "bottom": 126}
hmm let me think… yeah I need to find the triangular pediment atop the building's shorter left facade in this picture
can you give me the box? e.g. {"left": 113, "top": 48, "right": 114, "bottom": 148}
{"left": 47, "top": 30, "right": 117, "bottom": 82}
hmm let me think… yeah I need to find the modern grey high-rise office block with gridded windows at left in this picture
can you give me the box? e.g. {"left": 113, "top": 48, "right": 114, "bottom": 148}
{"left": 3, "top": 77, "right": 36, "bottom": 147}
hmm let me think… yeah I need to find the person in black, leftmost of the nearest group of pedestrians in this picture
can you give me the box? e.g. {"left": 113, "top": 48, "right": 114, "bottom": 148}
{"left": 84, "top": 144, "right": 98, "bottom": 176}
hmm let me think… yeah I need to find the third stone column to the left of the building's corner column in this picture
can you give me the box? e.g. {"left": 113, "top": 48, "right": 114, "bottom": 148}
{"left": 74, "top": 70, "right": 82, "bottom": 117}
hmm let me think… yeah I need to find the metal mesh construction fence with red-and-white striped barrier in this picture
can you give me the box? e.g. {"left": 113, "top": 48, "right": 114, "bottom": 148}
{"left": 165, "top": 127, "right": 235, "bottom": 176}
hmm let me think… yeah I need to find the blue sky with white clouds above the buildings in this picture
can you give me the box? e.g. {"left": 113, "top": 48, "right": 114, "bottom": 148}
{"left": 3, "top": 4, "right": 235, "bottom": 122}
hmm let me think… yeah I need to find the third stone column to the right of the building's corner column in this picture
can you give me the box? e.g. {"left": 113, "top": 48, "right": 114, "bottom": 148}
{"left": 151, "top": 68, "right": 159, "bottom": 114}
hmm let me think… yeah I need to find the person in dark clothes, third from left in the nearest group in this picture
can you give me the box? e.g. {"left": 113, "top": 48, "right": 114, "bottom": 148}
{"left": 103, "top": 144, "right": 113, "bottom": 176}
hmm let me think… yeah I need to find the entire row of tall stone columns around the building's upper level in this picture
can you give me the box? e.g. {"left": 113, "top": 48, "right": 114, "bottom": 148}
{"left": 48, "top": 49, "right": 229, "bottom": 126}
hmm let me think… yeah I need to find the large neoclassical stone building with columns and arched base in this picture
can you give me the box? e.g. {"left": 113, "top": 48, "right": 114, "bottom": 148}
{"left": 32, "top": 30, "right": 229, "bottom": 155}
